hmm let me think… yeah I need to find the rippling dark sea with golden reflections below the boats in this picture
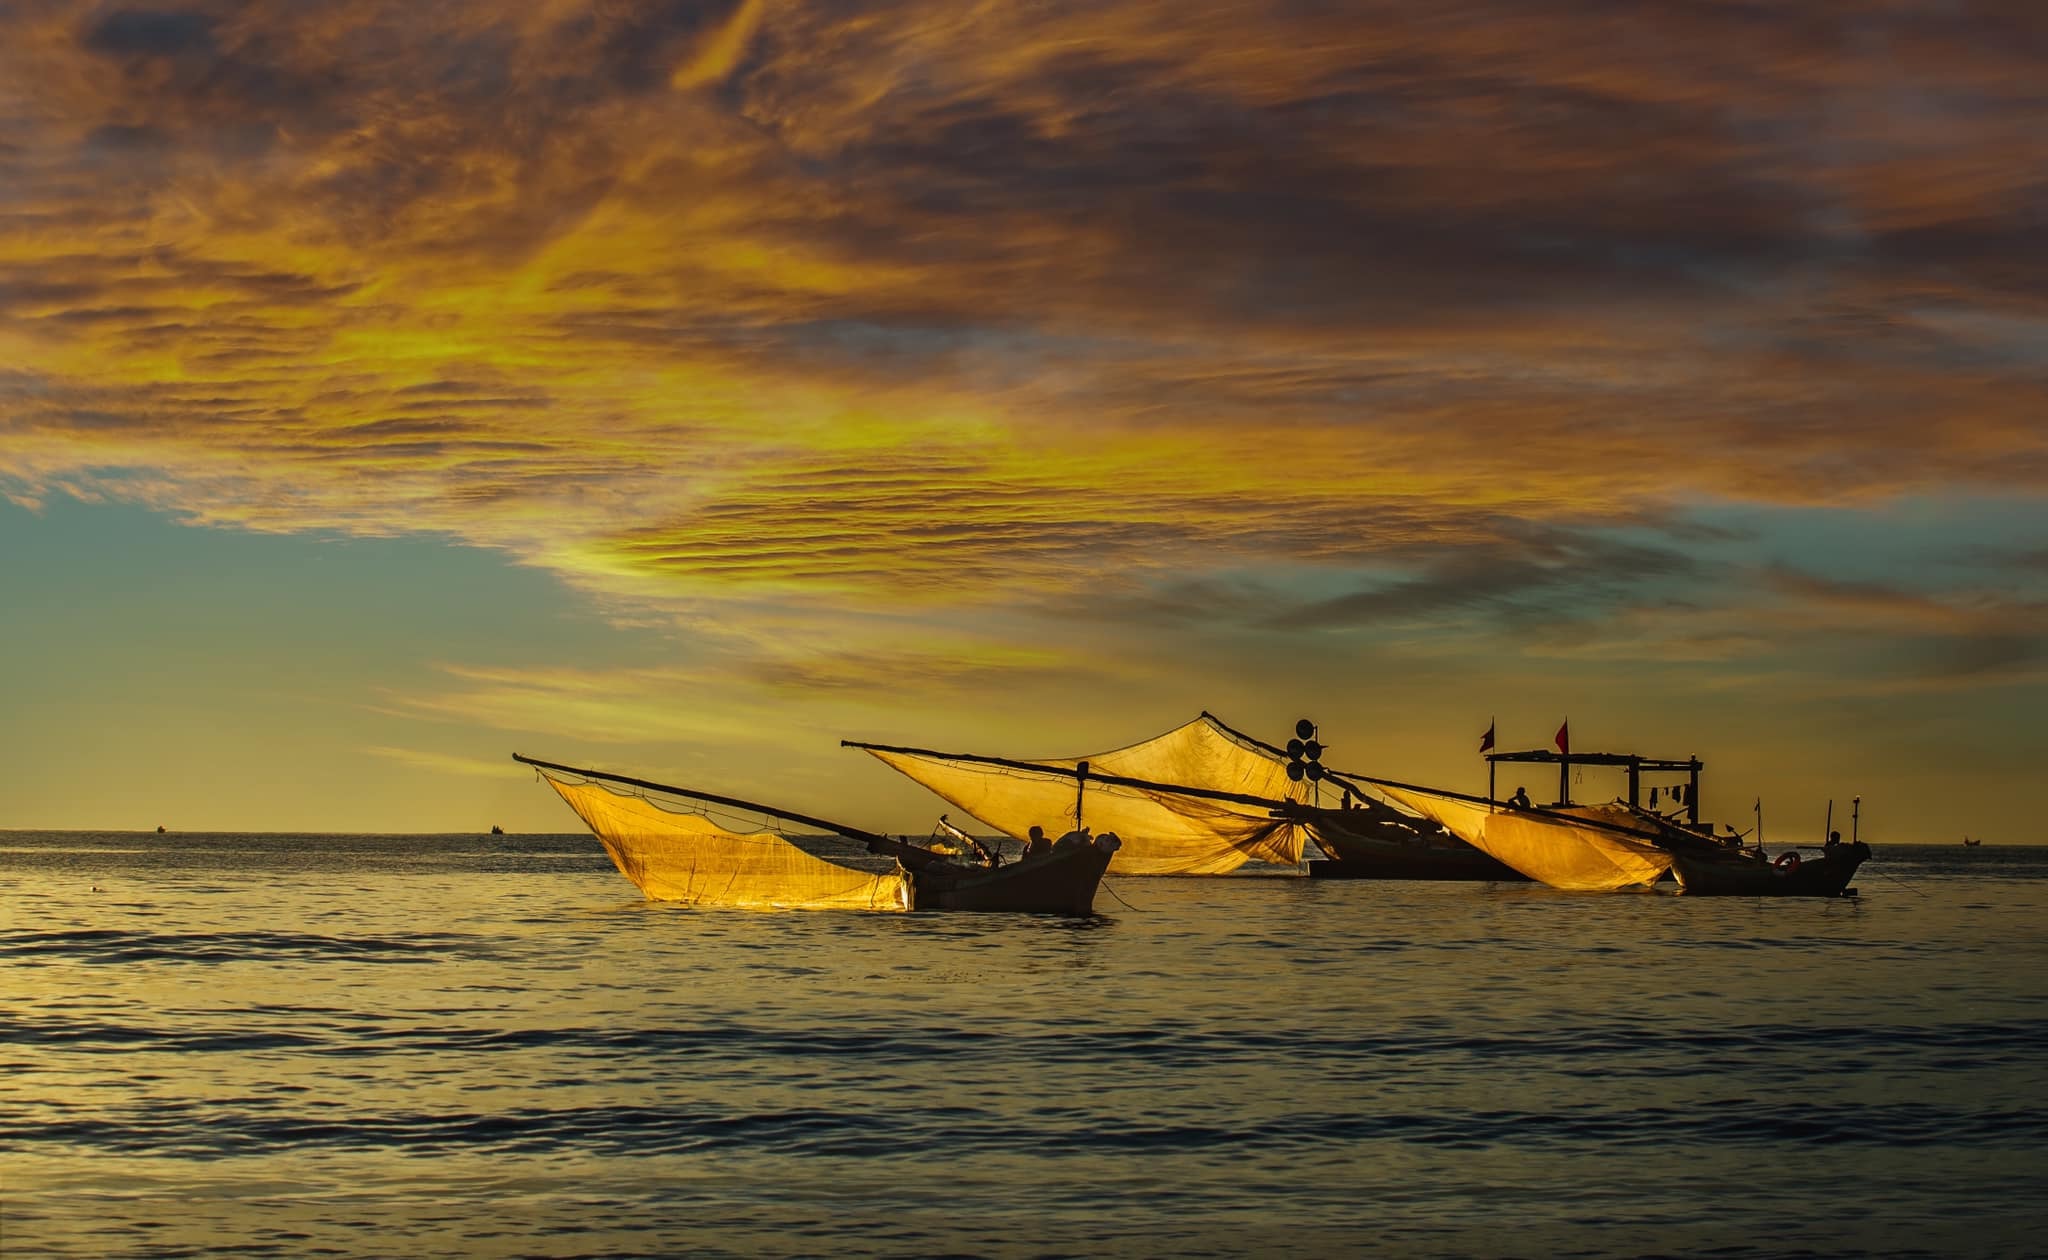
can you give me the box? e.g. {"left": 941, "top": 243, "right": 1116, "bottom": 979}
{"left": 0, "top": 832, "right": 2048, "bottom": 1260}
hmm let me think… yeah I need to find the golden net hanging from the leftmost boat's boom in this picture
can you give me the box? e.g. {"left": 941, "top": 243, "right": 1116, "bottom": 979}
{"left": 545, "top": 774, "right": 909, "bottom": 910}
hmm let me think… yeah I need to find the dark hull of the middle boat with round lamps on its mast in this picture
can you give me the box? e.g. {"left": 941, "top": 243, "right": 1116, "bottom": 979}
{"left": 1202, "top": 711, "right": 1528, "bottom": 881}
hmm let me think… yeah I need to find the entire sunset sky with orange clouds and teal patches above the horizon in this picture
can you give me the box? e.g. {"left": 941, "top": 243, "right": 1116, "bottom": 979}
{"left": 0, "top": 0, "right": 2048, "bottom": 842}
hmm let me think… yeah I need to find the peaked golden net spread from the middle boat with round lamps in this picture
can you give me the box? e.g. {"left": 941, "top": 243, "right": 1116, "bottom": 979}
{"left": 856, "top": 715, "right": 1305, "bottom": 875}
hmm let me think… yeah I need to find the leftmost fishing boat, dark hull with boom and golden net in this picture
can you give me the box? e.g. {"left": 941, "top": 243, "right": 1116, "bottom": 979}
{"left": 512, "top": 752, "right": 1118, "bottom": 914}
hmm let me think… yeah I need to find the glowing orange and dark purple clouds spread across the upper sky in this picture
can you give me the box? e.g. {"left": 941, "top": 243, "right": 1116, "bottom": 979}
{"left": 0, "top": 0, "right": 2048, "bottom": 700}
